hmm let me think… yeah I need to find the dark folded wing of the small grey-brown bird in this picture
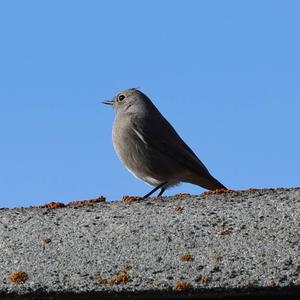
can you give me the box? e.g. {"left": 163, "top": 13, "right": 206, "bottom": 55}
{"left": 131, "top": 115, "right": 211, "bottom": 177}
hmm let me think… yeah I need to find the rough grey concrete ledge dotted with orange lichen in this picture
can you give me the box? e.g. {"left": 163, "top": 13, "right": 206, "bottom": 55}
{"left": 0, "top": 188, "right": 300, "bottom": 299}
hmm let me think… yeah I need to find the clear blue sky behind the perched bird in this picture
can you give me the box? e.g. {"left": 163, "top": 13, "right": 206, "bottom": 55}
{"left": 0, "top": 0, "right": 300, "bottom": 207}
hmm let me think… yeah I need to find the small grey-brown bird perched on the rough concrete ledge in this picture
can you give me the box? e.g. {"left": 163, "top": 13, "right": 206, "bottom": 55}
{"left": 102, "top": 88, "right": 227, "bottom": 198}
